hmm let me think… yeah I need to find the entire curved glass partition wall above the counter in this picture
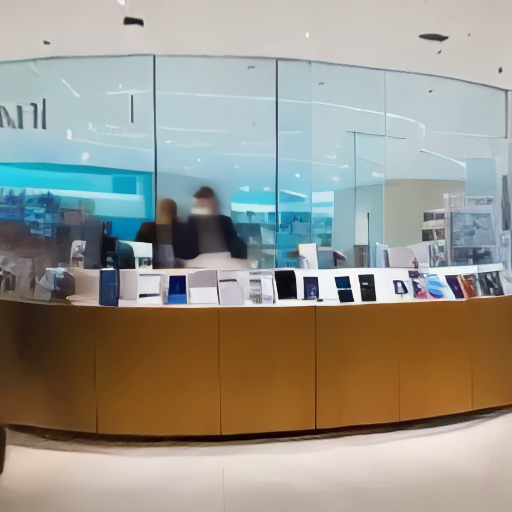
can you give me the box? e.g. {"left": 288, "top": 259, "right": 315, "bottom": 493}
{"left": 0, "top": 56, "right": 510, "bottom": 274}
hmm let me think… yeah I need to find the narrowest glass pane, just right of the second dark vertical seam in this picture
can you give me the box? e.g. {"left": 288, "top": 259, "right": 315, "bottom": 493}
{"left": 276, "top": 61, "right": 312, "bottom": 267}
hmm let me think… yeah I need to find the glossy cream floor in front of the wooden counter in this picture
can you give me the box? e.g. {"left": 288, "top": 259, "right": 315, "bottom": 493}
{"left": 0, "top": 414, "right": 512, "bottom": 512}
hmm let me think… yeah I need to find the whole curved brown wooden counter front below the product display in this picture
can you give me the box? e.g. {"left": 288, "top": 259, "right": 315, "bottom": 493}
{"left": 0, "top": 297, "right": 512, "bottom": 436}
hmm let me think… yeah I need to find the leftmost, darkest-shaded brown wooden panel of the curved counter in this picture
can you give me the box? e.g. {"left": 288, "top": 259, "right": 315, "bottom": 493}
{"left": 0, "top": 300, "right": 99, "bottom": 432}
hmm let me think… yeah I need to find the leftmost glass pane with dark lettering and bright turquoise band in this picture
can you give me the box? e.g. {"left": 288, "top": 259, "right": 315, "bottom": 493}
{"left": 0, "top": 57, "right": 154, "bottom": 280}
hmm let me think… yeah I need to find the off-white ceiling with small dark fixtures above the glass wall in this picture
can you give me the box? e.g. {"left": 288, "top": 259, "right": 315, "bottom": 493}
{"left": 0, "top": 0, "right": 512, "bottom": 89}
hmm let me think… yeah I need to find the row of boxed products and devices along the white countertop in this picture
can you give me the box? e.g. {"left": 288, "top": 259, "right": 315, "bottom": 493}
{"left": 89, "top": 265, "right": 508, "bottom": 307}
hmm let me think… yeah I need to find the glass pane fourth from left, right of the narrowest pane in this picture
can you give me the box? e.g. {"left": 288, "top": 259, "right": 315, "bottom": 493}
{"left": 311, "top": 63, "right": 385, "bottom": 267}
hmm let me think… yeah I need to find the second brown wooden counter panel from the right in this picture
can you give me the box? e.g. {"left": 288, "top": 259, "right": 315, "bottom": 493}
{"left": 400, "top": 301, "right": 474, "bottom": 421}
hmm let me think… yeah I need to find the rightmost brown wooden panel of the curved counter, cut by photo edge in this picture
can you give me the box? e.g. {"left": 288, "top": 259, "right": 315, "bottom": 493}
{"left": 468, "top": 297, "right": 512, "bottom": 409}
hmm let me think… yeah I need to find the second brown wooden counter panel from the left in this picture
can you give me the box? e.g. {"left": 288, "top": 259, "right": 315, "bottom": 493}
{"left": 97, "top": 306, "right": 220, "bottom": 436}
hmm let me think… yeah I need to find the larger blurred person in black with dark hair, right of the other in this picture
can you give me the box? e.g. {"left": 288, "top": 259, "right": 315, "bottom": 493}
{"left": 187, "top": 187, "right": 247, "bottom": 259}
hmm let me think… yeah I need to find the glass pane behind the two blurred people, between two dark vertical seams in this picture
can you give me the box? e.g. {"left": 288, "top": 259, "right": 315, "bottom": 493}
{"left": 156, "top": 57, "right": 276, "bottom": 268}
